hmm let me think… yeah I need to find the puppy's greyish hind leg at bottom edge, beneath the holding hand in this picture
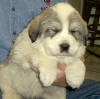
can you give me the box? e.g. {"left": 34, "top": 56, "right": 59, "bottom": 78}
{"left": 43, "top": 86, "right": 66, "bottom": 99}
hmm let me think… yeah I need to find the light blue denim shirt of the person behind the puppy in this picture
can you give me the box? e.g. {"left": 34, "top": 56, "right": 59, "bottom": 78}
{"left": 0, "top": 0, "right": 67, "bottom": 62}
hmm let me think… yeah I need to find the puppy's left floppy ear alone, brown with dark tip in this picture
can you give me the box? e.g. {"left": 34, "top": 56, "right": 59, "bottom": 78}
{"left": 28, "top": 15, "right": 41, "bottom": 42}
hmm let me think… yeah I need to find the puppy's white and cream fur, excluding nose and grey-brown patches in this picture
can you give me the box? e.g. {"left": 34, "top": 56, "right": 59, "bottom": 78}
{"left": 0, "top": 3, "right": 85, "bottom": 99}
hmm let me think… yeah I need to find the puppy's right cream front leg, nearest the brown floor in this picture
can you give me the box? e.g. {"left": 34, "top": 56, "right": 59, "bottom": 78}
{"left": 65, "top": 59, "right": 85, "bottom": 88}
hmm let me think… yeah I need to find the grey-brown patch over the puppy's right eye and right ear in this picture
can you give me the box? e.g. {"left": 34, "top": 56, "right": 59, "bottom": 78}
{"left": 69, "top": 12, "right": 88, "bottom": 43}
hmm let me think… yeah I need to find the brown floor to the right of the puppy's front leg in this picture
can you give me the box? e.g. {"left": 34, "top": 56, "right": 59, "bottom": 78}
{"left": 85, "top": 47, "right": 100, "bottom": 81}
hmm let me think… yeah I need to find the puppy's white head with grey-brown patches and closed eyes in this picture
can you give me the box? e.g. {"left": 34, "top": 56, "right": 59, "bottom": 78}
{"left": 29, "top": 3, "right": 87, "bottom": 57}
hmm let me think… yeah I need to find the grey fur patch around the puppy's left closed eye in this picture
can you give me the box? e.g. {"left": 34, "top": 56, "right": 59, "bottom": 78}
{"left": 40, "top": 13, "right": 62, "bottom": 38}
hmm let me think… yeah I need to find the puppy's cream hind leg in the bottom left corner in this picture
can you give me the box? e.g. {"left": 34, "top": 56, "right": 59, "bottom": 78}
{"left": 2, "top": 86, "right": 21, "bottom": 99}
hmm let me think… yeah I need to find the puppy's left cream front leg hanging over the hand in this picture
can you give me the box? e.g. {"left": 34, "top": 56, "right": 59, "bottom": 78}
{"left": 39, "top": 61, "right": 57, "bottom": 86}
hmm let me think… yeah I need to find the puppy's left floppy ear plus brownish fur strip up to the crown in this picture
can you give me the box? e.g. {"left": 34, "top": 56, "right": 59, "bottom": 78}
{"left": 29, "top": 7, "right": 53, "bottom": 42}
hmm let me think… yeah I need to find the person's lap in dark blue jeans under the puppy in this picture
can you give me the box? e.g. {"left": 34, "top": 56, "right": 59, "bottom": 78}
{"left": 0, "top": 80, "right": 100, "bottom": 99}
